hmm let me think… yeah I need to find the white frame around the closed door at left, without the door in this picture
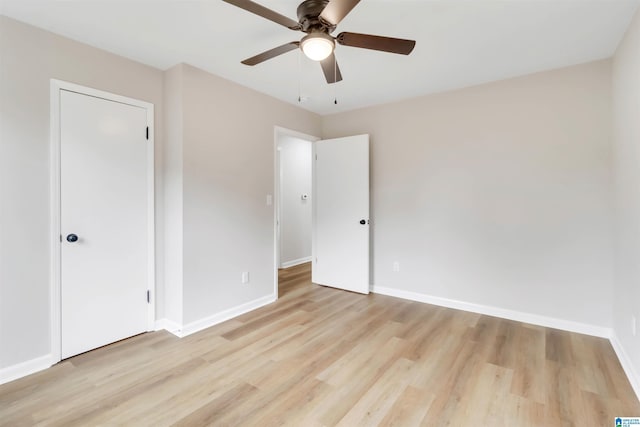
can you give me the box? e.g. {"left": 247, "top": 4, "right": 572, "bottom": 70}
{"left": 49, "top": 79, "right": 156, "bottom": 363}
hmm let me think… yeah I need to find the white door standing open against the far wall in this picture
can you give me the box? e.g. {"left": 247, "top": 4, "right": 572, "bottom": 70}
{"left": 311, "top": 135, "right": 369, "bottom": 294}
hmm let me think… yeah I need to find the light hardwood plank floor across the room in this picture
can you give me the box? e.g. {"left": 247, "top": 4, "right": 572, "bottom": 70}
{"left": 0, "top": 264, "right": 640, "bottom": 427}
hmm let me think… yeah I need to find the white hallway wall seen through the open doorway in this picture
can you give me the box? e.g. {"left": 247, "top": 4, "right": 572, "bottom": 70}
{"left": 278, "top": 135, "right": 312, "bottom": 267}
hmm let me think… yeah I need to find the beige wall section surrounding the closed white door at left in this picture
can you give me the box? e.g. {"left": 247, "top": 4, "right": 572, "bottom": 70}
{"left": 0, "top": 16, "right": 168, "bottom": 369}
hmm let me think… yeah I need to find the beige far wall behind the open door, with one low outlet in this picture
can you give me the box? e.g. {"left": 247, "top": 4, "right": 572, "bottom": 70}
{"left": 323, "top": 60, "right": 613, "bottom": 327}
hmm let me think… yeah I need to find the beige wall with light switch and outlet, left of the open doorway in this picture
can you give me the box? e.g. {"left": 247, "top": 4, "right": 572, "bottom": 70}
{"left": 182, "top": 65, "right": 321, "bottom": 324}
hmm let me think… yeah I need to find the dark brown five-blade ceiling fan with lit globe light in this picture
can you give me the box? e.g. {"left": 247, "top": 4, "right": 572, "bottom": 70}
{"left": 223, "top": 0, "right": 416, "bottom": 83}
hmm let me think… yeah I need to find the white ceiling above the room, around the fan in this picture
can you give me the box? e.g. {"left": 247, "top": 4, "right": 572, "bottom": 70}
{"left": 0, "top": 0, "right": 639, "bottom": 114}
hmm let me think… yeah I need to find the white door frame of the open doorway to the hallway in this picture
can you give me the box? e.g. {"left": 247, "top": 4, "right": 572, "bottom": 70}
{"left": 273, "top": 126, "right": 320, "bottom": 299}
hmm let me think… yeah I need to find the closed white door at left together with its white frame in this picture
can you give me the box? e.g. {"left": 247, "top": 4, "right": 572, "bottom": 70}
{"left": 51, "top": 80, "right": 155, "bottom": 360}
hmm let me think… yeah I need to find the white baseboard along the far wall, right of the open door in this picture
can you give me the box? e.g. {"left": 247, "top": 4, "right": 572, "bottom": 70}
{"left": 371, "top": 285, "right": 612, "bottom": 338}
